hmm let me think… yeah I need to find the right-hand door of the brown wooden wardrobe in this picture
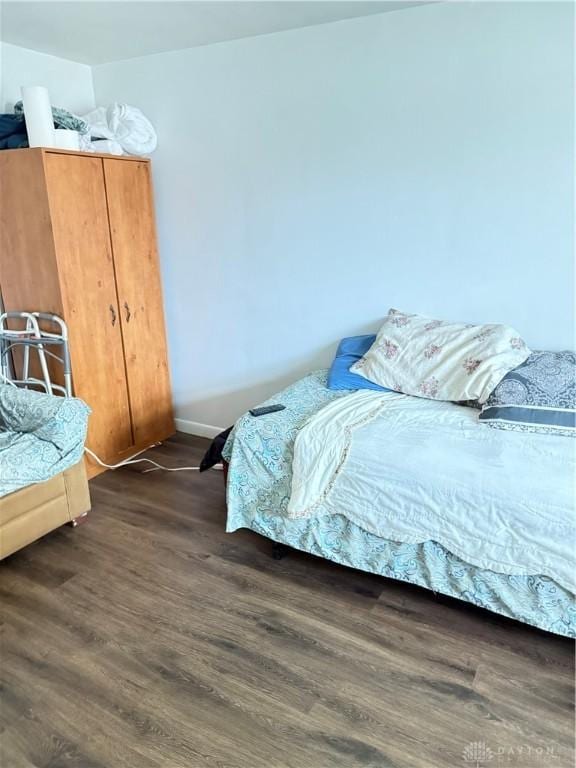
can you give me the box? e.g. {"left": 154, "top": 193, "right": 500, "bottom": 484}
{"left": 103, "top": 158, "right": 174, "bottom": 446}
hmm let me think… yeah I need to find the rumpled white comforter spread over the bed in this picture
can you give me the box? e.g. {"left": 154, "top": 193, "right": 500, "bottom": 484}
{"left": 288, "top": 391, "right": 576, "bottom": 592}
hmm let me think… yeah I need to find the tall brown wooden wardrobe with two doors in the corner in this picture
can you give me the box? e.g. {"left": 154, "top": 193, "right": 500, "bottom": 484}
{"left": 0, "top": 149, "right": 174, "bottom": 476}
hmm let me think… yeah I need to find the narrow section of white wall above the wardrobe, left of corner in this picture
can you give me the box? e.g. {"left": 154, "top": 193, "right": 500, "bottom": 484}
{"left": 0, "top": 43, "right": 94, "bottom": 114}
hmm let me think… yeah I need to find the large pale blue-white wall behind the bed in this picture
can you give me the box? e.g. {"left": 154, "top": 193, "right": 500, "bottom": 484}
{"left": 94, "top": 3, "right": 574, "bottom": 427}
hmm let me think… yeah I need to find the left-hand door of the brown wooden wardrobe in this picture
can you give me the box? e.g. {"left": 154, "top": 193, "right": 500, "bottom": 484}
{"left": 44, "top": 153, "right": 133, "bottom": 474}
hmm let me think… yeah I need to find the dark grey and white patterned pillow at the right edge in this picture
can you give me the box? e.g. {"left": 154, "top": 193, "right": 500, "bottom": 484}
{"left": 479, "top": 352, "right": 576, "bottom": 437}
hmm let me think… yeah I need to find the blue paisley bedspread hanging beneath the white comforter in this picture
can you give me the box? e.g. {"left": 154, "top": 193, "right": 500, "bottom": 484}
{"left": 223, "top": 371, "right": 576, "bottom": 637}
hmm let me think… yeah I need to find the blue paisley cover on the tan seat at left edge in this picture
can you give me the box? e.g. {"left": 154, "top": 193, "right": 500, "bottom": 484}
{"left": 0, "top": 384, "right": 90, "bottom": 497}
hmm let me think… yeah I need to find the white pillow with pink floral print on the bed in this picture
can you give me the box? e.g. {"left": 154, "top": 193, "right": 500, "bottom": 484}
{"left": 350, "top": 309, "right": 530, "bottom": 403}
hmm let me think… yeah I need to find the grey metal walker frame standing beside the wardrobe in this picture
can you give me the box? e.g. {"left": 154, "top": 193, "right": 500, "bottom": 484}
{"left": 0, "top": 312, "right": 72, "bottom": 397}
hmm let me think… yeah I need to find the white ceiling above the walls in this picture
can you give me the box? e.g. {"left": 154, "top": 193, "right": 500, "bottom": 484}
{"left": 0, "top": 0, "right": 427, "bottom": 65}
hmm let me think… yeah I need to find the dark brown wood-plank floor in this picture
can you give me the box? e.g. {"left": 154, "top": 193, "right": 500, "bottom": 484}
{"left": 0, "top": 435, "right": 574, "bottom": 768}
